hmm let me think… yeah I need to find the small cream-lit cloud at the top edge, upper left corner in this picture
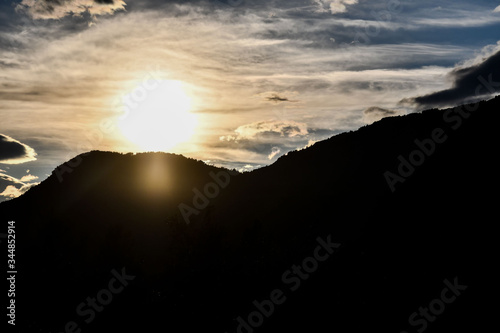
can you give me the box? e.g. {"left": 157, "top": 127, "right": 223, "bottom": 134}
{"left": 16, "top": 0, "right": 126, "bottom": 19}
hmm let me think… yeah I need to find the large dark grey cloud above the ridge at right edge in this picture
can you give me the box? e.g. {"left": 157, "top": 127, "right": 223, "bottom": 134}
{"left": 401, "top": 52, "right": 500, "bottom": 108}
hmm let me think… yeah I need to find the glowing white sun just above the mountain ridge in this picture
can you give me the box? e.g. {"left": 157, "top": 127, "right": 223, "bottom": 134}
{"left": 118, "top": 80, "right": 197, "bottom": 151}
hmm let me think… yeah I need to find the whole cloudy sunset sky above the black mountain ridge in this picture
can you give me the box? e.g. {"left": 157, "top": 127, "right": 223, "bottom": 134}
{"left": 0, "top": 0, "right": 500, "bottom": 201}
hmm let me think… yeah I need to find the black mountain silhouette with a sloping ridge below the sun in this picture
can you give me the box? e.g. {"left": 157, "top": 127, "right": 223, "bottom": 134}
{"left": 0, "top": 97, "right": 500, "bottom": 333}
